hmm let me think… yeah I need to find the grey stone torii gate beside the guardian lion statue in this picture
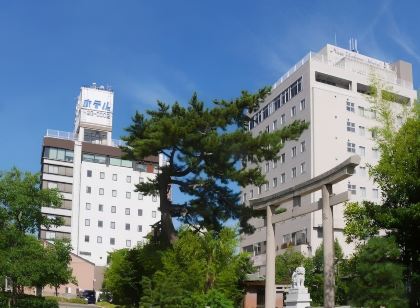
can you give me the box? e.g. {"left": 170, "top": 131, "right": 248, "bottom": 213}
{"left": 250, "top": 155, "right": 360, "bottom": 308}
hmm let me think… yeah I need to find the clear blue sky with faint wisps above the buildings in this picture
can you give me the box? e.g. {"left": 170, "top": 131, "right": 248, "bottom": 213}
{"left": 0, "top": 0, "right": 420, "bottom": 176}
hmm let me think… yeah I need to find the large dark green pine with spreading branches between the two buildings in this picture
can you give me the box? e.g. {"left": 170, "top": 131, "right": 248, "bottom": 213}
{"left": 123, "top": 88, "right": 308, "bottom": 243}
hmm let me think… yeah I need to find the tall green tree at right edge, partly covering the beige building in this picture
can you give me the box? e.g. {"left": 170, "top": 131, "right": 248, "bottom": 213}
{"left": 345, "top": 84, "right": 420, "bottom": 307}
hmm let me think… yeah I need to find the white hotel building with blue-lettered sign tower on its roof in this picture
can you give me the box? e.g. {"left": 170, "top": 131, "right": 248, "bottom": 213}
{"left": 40, "top": 85, "right": 160, "bottom": 266}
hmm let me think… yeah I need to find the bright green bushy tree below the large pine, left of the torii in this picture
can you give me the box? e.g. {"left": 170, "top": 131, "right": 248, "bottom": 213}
{"left": 141, "top": 228, "right": 253, "bottom": 307}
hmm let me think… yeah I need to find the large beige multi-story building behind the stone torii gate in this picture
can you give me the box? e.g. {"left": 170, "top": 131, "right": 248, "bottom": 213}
{"left": 241, "top": 45, "right": 417, "bottom": 274}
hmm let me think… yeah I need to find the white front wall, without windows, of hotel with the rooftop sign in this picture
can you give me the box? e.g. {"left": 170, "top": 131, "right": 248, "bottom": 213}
{"left": 77, "top": 161, "right": 160, "bottom": 265}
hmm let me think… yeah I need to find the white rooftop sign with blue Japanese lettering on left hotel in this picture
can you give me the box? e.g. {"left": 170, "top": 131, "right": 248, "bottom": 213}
{"left": 75, "top": 87, "right": 114, "bottom": 131}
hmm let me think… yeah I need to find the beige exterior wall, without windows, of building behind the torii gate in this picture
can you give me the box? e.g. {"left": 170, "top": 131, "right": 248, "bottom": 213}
{"left": 241, "top": 45, "right": 416, "bottom": 275}
